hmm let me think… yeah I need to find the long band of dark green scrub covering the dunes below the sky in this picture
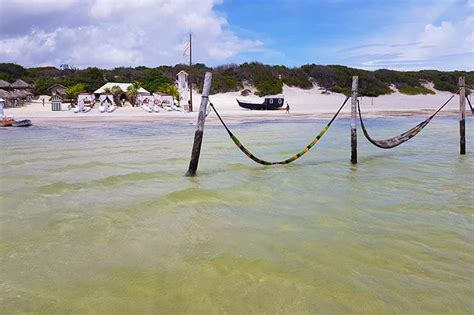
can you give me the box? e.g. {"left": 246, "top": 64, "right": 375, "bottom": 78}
{"left": 0, "top": 62, "right": 474, "bottom": 96}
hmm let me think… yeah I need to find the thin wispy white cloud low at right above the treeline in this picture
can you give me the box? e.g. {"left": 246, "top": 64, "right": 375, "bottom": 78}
{"left": 345, "top": 16, "right": 474, "bottom": 70}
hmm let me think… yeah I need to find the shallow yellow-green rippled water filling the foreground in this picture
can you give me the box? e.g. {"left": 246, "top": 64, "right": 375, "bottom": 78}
{"left": 0, "top": 118, "right": 474, "bottom": 314}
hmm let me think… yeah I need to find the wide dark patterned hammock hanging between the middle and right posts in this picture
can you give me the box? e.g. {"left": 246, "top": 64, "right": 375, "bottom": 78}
{"left": 357, "top": 94, "right": 456, "bottom": 149}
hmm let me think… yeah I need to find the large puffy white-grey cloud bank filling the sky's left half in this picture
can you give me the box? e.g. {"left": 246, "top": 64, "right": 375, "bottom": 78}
{"left": 0, "top": 0, "right": 263, "bottom": 67}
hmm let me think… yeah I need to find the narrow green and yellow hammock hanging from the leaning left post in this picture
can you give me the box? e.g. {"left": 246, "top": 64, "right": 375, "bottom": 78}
{"left": 209, "top": 96, "right": 350, "bottom": 165}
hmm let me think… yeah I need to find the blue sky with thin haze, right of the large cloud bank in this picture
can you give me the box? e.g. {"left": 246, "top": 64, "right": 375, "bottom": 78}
{"left": 217, "top": 0, "right": 473, "bottom": 70}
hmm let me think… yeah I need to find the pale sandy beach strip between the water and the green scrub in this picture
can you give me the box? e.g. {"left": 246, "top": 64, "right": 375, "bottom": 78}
{"left": 1, "top": 86, "right": 464, "bottom": 126}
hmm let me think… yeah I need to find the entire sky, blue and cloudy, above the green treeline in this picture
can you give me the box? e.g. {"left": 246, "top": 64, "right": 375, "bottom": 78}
{"left": 0, "top": 0, "right": 474, "bottom": 71}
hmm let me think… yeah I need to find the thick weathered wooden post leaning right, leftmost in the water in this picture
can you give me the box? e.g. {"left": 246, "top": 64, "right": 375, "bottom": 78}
{"left": 186, "top": 72, "right": 212, "bottom": 176}
